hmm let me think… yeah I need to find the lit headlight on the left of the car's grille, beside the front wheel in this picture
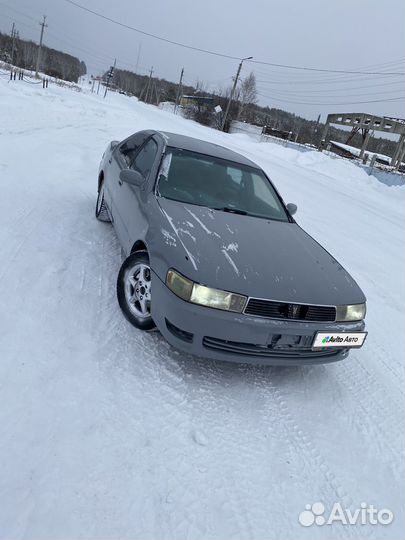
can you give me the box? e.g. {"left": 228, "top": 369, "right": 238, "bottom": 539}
{"left": 166, "top": 270, "right": 246, "bottom": 313}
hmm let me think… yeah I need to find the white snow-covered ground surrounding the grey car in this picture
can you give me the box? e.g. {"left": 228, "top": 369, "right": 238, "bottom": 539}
{"left": 0, "top": 77, "right": 405, "bottom": 540}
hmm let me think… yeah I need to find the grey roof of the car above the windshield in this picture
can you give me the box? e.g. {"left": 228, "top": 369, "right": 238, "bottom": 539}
{"left": 153, "top": 131, "right": 260, "bottom": 169}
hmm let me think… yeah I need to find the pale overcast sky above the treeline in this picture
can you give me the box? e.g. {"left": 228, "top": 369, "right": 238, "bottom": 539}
{"left": 0, "top": 0, "right": 405, "bottom": 119}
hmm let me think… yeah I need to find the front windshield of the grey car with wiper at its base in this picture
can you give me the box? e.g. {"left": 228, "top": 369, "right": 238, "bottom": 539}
{"left": 157, "top": 148, "right": 289, "bottom": 221}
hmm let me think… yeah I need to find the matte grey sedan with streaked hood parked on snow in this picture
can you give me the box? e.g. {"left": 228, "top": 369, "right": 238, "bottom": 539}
{"left": 96, "top": 130, "right": 366, "bottom": 365}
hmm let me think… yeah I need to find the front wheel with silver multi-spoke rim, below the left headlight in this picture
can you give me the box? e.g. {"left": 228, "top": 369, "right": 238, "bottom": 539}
{"left": 117, "top": 251, "right": 155, "bottom": 330}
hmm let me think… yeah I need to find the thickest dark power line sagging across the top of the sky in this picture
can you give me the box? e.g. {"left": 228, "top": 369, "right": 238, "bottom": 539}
{"left": 65, "top": 0, "right": 404, "bottom": 75}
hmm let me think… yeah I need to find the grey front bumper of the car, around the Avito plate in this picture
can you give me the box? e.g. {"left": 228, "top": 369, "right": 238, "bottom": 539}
{"left": 152, "top": 272, "right": 365, "bottom": 365}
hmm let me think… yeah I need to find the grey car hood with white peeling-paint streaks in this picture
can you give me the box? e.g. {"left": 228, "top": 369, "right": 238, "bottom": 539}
{"left": 153, "top": 198, "right": 365, "bottom": 305}
